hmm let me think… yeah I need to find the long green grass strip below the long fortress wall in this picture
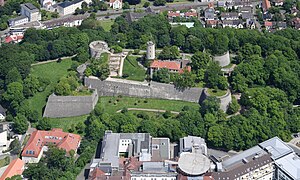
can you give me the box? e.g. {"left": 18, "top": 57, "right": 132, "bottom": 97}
{"left": 98, "top": 97, "right": 199, "bottom": 114}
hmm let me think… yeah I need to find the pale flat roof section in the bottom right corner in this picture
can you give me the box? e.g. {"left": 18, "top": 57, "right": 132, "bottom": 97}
{"left": 275, "top": 153, "right": 300, "bottom": 179}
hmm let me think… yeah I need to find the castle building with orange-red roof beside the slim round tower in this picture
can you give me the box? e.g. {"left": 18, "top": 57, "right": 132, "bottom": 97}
{"left": 150, "top": 60, "right": 191, "bottom": 77}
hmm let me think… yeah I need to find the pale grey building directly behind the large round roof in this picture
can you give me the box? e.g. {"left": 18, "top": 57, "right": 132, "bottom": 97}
{"left": 179, "top": 136, "right": 207, "bottom": 155}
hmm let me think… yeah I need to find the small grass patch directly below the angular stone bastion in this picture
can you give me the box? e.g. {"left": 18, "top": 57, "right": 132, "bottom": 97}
{"left": 49, "top": 115, "right": 88, "bottom": 132}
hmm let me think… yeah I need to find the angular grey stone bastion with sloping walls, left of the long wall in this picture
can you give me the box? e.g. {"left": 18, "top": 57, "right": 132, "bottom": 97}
{"left": 43, "top": 91, "right": 98, "bottom": 118}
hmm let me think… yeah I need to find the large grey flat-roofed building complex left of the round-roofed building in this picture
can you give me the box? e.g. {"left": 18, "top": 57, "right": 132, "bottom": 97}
{"left": 89, "top": 131, "right": 173, "bottom": 180}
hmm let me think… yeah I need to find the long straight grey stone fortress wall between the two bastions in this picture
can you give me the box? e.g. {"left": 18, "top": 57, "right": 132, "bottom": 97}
{"left": 85, "top": 77, "right": 203, "bottom": 103}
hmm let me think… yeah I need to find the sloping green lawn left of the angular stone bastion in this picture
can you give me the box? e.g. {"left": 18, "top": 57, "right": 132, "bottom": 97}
{"left": 28, "top": 59, "right": 72, "bottom": 114}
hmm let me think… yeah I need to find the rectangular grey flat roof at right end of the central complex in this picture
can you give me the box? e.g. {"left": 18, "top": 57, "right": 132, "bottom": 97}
{"left": 151, "top": 138, "right": 170, "bottom": 161}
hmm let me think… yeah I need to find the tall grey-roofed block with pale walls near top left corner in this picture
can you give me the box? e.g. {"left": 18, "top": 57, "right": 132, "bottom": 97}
{"left": 21, "top": 3, "right": 42, "bottom": 22}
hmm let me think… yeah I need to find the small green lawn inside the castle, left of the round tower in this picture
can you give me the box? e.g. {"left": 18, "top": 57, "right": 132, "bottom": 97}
{"left": 123, "top": 56, "right": 146, "bottom": 81}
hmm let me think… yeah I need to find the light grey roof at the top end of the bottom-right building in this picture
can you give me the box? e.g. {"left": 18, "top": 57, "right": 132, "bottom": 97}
{"left": 259, "top": 136, "right": 293, "bottom": 160}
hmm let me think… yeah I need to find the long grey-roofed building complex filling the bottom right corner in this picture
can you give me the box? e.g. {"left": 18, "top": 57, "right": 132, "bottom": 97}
{"left": 204, "top": 137, "right": 300, "bottom": 180}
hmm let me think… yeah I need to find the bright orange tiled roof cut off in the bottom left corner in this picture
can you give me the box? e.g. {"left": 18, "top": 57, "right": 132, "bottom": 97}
{"left": 0, "top": 158, "right": 24, "bottom": 180}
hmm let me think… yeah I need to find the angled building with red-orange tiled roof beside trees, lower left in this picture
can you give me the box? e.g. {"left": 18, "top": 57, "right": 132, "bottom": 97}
{"left": 21, "top": 129, "right": 81, "bottom": 163}
